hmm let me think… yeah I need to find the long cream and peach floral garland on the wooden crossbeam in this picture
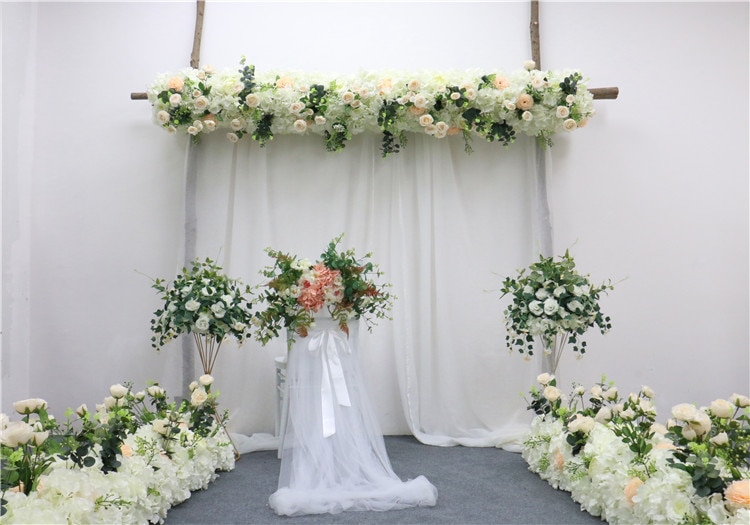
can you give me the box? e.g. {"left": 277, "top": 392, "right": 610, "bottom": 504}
{"left": 147, "top": 57, "right": 594, "bottom": 157}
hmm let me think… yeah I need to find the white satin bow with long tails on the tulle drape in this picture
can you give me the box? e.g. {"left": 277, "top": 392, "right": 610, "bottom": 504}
{"left": 307, "top": 329, "right": 352, "bottom": 437}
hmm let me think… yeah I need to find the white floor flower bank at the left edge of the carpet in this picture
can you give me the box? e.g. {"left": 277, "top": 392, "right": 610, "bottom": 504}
{"left": 0, "top": 375, "right": 235, "bottom": 524}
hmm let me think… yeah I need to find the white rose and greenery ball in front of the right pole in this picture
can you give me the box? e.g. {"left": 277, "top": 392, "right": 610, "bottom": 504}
{"left": 500, "top": 250, "right": 613, "bottom": 373}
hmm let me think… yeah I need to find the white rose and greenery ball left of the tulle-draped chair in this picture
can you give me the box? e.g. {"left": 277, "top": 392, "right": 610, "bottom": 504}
{"left": 151, "top": 258, "right": 252, "bottom": 374}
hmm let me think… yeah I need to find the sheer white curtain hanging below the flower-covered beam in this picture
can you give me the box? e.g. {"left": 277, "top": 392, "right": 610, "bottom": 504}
{"left": 188, "top": 130, "right": 538, "bottom": 446}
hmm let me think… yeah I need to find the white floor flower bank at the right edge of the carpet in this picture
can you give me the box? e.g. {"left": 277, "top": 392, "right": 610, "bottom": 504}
{"left": 522, "top": 374, "right": 750, "bottom": 525}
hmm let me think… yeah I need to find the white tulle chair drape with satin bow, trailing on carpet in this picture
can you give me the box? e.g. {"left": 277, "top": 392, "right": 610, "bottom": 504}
{"left": 269, "top": 318, "right": 437, "bottom": 516}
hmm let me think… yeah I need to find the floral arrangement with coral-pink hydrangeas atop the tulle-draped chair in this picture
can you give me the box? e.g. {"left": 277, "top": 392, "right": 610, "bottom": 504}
{"left": 252, "top": 234, "right": 395, "bottom": 345}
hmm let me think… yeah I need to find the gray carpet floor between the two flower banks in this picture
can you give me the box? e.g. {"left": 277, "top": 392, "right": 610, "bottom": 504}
{"left": 165, "top": 436, "right": 602, "bottom": 525}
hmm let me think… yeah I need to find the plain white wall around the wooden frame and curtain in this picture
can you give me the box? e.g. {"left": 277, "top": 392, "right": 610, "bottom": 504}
{"left": 0, "top": 1, "right": 750, "bottom": 433}
